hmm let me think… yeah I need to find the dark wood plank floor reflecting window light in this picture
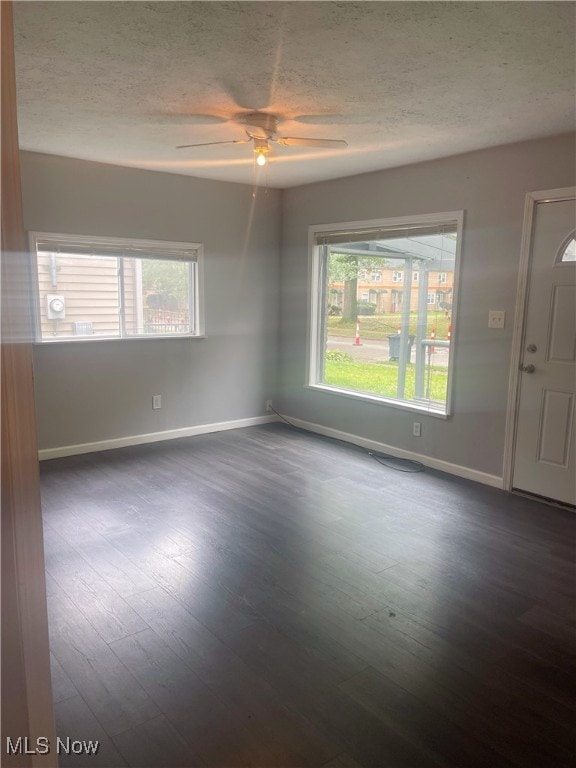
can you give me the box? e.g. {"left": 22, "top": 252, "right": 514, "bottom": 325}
{"left": 42, "top": 424, "right": 576, "bottom": 768}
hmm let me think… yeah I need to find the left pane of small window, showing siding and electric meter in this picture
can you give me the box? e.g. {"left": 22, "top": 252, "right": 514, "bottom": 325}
{"left": 38, "top": 251, "right": 120, "bottom": 341}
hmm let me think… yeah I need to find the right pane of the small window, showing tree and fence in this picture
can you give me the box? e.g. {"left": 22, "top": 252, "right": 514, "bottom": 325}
{"left": 123, "top": 258, "right": 193, "bottom": 336}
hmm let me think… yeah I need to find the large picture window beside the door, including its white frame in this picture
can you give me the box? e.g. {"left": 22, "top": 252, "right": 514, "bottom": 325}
{"left": 307, "top": 212, "right": 463, "bottom": 416}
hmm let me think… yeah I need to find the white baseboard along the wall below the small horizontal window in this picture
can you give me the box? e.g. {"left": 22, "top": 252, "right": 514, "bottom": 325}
{"left": 38, "top": 415, "right": 279, "bottom": 461}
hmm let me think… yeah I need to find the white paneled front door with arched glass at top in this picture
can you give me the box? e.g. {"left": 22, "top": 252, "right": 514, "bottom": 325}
{"left": 512, "top": 194, "right": 576, "bottom": 505}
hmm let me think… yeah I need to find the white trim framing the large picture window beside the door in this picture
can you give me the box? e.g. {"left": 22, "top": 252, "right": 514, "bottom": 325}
{"left": 303, "top": 210, "right": 464, "bottom": 419}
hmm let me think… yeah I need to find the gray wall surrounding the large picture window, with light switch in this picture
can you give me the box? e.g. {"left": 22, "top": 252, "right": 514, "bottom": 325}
{"left": 279, "top": 135, "right": 575, "bottom": 476}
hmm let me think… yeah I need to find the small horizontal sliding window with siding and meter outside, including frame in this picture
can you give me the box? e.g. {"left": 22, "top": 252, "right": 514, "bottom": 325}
{"left": 30, "top": 232, "right": 202, "bottom": 342}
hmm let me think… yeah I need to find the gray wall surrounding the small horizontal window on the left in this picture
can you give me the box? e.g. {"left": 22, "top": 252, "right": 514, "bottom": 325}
{"left": 22, "top": 152, "right": 281, "bottom": 448}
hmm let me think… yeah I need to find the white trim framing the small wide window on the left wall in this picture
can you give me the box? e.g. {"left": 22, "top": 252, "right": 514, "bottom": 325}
{"left": 28, "top": 231, "right": 206, "bottom": 345}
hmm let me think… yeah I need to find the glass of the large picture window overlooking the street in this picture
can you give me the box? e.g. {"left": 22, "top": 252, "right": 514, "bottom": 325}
{"left": 316, "top": 225, "right": 457, "bottom": 413}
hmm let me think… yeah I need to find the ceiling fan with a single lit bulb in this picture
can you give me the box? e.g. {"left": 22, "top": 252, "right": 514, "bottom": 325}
{"left": 176, "top": 112, "right": 348, "bottom": 165}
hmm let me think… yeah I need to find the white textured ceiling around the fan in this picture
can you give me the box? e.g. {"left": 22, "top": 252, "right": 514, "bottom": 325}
{"left": 14, "top": 1, "right": 576, "bottom": 187}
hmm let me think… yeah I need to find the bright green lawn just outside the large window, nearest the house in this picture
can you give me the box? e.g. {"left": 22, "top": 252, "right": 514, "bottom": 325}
{"left": 324, "top": 360, "right": 448, "bottom": 403}
